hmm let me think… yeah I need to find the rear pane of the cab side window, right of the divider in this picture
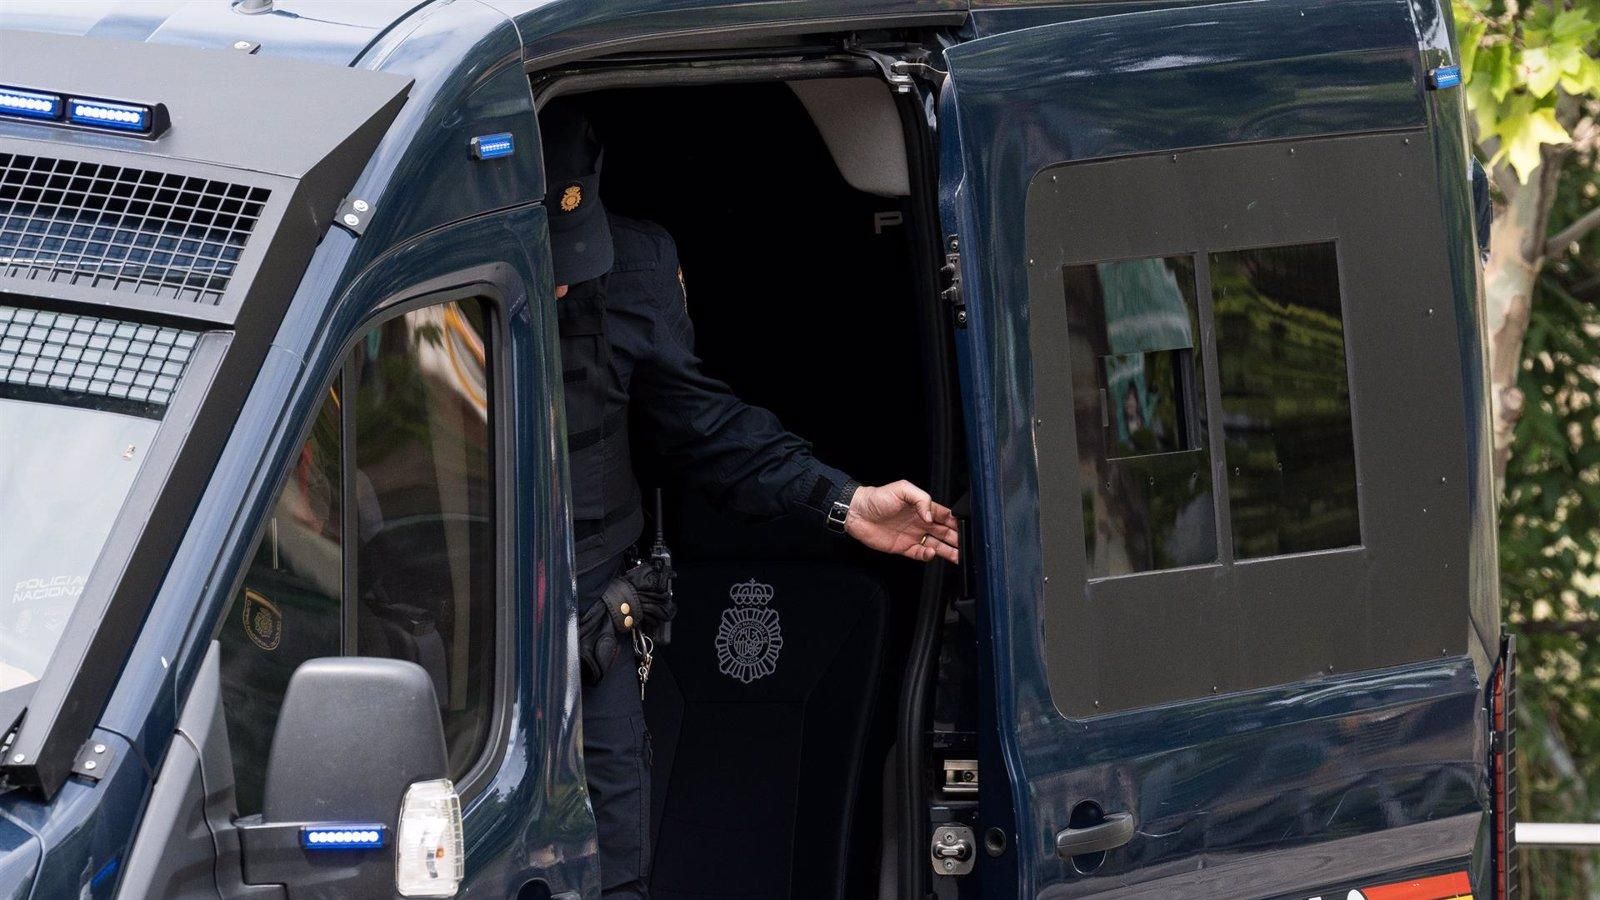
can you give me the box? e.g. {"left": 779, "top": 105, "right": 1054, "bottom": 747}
{"left": 354, "top": 301, "right": 494, "bottom": 778}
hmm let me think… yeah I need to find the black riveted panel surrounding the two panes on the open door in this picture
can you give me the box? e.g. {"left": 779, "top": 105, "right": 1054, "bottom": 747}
{"left": 1021, "top": 131, "right": 1472, "bottom": 719}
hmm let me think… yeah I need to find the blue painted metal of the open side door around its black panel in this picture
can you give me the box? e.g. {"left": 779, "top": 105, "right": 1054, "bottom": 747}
{"left": 942, "top": 0, "right": 1494, "bottom": 897}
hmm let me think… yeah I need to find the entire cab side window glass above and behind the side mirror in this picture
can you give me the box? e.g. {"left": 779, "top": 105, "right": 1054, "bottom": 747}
{"left": 219, "top": 301, "right": 494, "bottom": 815}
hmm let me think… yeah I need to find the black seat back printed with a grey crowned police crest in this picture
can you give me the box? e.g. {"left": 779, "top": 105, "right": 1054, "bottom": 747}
{"left": 645, "top": 560, "right": 888, "bottom": 900}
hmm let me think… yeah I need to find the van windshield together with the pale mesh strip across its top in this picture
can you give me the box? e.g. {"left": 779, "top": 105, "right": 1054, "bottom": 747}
{"left": 0, "top": 306, "right": 195, "bottom": 692}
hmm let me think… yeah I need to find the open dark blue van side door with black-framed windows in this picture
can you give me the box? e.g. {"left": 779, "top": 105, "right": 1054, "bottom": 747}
{"left": 941, "top": 0, "right": 1494, "bottom": 897}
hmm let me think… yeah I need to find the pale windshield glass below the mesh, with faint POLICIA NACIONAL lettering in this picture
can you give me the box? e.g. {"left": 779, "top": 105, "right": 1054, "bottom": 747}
{"left": 0, "top": 389, "right": 160, "bottom": 692}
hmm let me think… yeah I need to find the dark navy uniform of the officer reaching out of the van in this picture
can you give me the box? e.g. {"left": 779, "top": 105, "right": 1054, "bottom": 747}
{"left": 547, "top": 104, "right": 854, "bottom": 897}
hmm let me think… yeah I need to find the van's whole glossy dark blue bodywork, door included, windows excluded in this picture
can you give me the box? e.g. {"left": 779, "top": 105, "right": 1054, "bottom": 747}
{"left": 0, "top": 0, "right": 1498, "bottom": 900}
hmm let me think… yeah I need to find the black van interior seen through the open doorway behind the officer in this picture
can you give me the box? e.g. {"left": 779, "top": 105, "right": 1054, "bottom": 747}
{"left": 544, "top": 78, "right": 958, "bottom": 900}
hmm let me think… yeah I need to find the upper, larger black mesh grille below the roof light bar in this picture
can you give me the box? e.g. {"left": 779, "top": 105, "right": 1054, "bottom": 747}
{"left": 0, "top": 154, "right": 270, "bottom": 304}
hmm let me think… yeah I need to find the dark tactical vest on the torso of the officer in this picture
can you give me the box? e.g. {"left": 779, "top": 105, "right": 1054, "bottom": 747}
{"left": 555, "top": 279, "right": 645, "bottom": 575}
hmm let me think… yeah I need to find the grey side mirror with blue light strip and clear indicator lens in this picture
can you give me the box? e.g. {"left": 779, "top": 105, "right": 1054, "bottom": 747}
{"left": 237, "top": 657, "right": 462, "bottom": 898}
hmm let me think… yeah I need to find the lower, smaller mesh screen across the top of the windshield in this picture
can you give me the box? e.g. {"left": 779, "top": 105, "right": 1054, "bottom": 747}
{"left": 0, "top": 306, "right": 198, "bottom": 407}
